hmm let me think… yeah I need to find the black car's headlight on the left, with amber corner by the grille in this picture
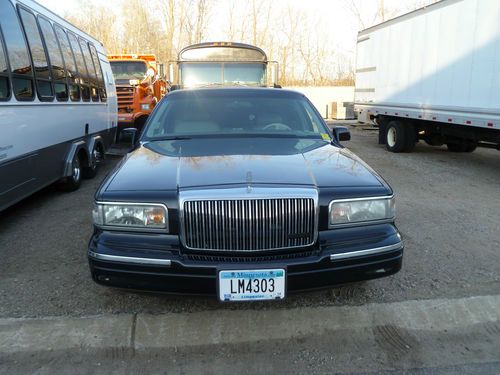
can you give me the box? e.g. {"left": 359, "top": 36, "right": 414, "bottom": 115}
{"left": 92, "top": 203, "right": 168, "bottom": 230}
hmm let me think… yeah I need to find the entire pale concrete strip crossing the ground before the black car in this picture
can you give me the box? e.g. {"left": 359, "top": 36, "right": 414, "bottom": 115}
{"left": 0, "top": 295, "right": 500, "bottom": 358}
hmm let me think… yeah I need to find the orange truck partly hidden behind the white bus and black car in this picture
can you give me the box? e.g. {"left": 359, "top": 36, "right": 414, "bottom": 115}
{"left": 108, "top": 54, "right": 167, "bottom": 131}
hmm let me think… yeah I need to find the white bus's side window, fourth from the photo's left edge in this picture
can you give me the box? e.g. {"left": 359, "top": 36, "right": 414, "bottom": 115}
{"left": 38, "top": 16, "right": 68, "bottom": 101}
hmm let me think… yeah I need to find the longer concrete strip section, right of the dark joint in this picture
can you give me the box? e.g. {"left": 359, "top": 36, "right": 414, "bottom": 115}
{"left": 134, "top": 296, "right": 500, "bottom": 349}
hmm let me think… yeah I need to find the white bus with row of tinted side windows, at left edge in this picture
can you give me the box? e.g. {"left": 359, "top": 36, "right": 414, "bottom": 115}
{"left": 0, "top": 0, "right": 117, "bottom": 211}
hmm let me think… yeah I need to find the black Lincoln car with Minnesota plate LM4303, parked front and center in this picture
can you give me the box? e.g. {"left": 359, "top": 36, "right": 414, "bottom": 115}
{"left": 88, "top": 87, "right": 403, "bottom": 301}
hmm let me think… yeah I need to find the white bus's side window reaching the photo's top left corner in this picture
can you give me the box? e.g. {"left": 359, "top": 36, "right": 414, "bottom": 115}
{"left": 0, "top": 1, "right": 34, "bottom": 100}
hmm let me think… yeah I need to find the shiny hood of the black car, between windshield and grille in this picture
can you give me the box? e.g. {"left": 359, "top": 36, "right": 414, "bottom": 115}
{"left": 106, "top": 138, "right": 384, "bottom": 191}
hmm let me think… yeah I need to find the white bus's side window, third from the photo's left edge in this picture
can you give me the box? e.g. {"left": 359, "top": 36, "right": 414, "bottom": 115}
{"left": 19, "top": 8, "right": 54, "bottom": 101}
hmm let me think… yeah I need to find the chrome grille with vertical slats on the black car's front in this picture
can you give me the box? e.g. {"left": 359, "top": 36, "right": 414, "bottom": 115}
{"left": 183, "top": 198, "right": 317, "bottom": 251}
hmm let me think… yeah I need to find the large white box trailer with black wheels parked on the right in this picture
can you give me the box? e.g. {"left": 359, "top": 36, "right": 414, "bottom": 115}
{"left": 355, "top": 0, "right": 500, "bottom": 152}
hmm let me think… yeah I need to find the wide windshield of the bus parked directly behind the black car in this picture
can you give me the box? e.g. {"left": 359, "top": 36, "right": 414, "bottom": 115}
{"left": 180, "top": 63, "right": 266, "bottom": 87}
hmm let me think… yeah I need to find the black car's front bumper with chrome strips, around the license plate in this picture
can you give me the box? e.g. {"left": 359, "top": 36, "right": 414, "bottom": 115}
{"left": 88, "top": 224, "right": 404, "bottom": 296}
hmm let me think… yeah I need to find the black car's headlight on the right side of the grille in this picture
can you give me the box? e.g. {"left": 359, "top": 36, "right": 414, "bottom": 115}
{"left": 329, "top": 197, "right": 396, "bottom": 227}
